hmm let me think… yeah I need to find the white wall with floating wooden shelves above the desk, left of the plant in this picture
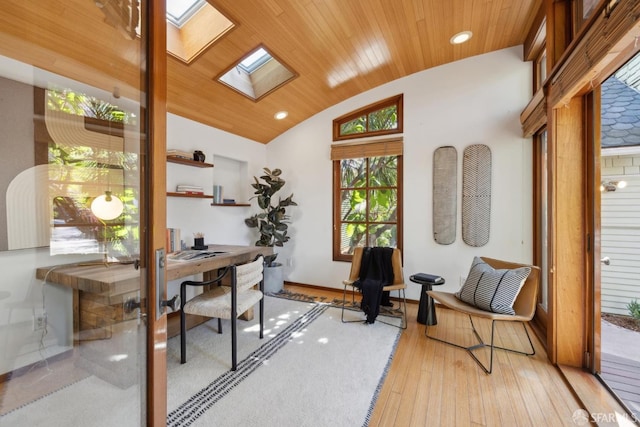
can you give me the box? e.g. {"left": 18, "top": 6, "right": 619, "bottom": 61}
{"left": 167, "top": 114, "right": 267, "bottom": 296}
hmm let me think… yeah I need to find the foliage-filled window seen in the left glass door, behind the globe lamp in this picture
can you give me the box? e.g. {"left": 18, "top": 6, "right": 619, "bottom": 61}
{"left": 39, "top": 89, "right": 140, "bottom": 257}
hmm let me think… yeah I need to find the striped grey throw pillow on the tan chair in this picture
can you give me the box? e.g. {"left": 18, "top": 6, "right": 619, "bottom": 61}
{"left": 455, "top": 257, "right": 531, "bottom": 314}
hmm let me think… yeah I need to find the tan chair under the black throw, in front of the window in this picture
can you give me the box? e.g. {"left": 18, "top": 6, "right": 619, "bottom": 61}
{"left": 341, "top": 246, "right": 407, "bottom": 329}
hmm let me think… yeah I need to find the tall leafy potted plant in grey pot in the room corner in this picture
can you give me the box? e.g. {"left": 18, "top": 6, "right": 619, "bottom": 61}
{"left": 244, "top": 168, "right": 298, "bottom": 293}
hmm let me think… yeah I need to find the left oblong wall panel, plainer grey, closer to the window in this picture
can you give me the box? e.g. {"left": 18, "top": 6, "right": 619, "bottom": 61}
{"left": 433, "top": 146, "right": 458, "bottom": 245}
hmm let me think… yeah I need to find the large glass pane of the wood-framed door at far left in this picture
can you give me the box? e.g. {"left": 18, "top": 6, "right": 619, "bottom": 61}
{"left": 0, "top": 0, "right": 153, "bottom": 426}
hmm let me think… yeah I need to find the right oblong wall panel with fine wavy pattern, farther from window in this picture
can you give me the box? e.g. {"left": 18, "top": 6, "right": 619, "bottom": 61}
{"left": 462, "top": 144, "right": 491, "bottom": 247}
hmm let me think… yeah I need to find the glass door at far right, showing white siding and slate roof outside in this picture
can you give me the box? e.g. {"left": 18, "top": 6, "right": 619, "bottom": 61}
{"left": 594, "top": 56, "right": 640, "bottom": 420}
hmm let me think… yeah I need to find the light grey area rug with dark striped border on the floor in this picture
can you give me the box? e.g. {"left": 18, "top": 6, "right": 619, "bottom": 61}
{"left": 167, "top": 297, "right": 400, "bottom": 427}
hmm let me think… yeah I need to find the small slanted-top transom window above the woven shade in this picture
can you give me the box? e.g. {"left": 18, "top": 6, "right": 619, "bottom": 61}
{"left": 333, "top": 95, "right": 402, "bottom": 141}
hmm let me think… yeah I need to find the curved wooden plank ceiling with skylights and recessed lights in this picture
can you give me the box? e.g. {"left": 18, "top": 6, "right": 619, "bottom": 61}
{"left": 0, "top": 0, "right": 542, "bottom": 143}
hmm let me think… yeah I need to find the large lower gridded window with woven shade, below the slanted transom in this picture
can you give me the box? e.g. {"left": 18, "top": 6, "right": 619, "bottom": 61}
{"left": 331, "top": 139, "right": 403, "bottom": 261}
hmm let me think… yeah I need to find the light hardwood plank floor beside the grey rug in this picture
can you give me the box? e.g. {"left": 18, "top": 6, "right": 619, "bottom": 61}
{"left": 287, "top": 286, "right": 582, "bottom": 427}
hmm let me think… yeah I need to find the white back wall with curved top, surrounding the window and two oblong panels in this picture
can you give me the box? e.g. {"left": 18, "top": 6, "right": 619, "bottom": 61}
{"left": 267, "top": 47, "right": 532, "bottom": 299}
